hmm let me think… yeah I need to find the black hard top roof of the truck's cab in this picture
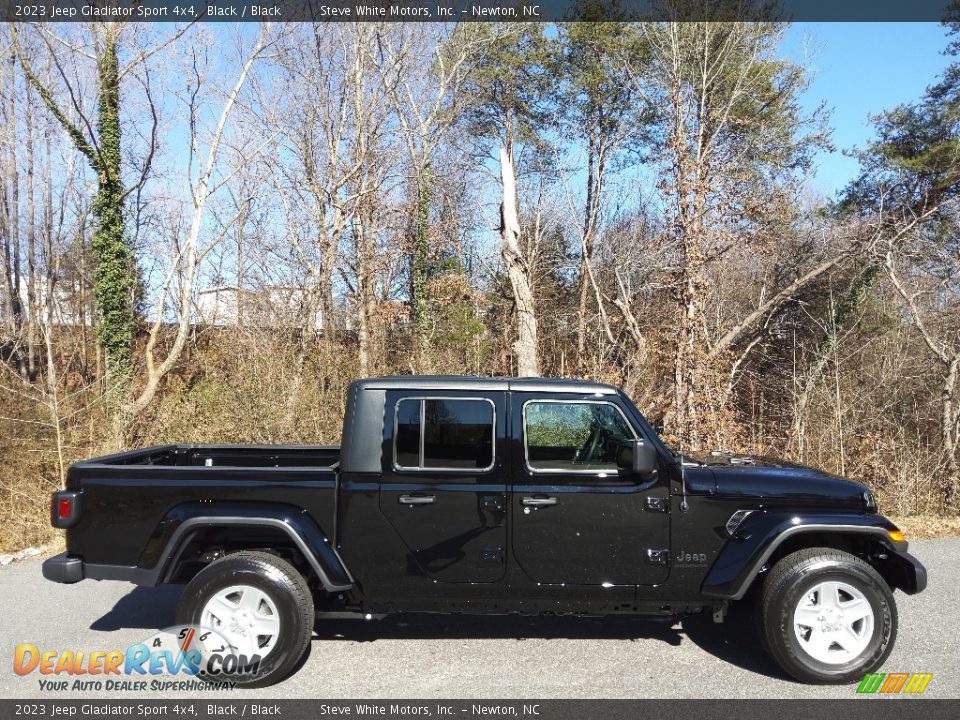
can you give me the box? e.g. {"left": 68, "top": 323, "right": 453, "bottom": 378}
{"left": 356, "top": 375, "right": 618, "bottom": 395}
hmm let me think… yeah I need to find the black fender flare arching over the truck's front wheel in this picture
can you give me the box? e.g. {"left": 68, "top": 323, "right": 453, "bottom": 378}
{"left": 700, "top": 511, "right": 908, "bottom": 600}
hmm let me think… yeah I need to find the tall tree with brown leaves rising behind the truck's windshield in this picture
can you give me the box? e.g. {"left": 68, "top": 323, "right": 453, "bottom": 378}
{"left": 632, "top": 22, "right": 822, "bottom": 448}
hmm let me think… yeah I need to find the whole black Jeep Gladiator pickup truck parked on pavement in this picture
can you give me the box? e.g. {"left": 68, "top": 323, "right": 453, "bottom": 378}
{"left": 43, "top": 377, "right": 927, "bottom": 685}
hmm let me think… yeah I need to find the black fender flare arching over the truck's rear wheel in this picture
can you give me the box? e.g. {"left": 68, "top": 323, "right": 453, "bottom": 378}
{"left": 130, "top": 503, "right": 354, "bottom": 592}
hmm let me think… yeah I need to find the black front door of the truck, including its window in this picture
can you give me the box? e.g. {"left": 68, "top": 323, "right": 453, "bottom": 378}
{"left": 511, "top": 394, "right": 670, "bottom": 585}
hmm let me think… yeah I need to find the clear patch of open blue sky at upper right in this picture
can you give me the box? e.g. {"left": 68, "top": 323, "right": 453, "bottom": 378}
{"left": 781, "top": 23, "right": 951, "bottom": 195}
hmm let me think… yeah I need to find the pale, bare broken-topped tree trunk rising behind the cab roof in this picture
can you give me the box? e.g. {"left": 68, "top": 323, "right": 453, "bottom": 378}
{"left": 500, "top": 146, "right": 540, "bottom": 377}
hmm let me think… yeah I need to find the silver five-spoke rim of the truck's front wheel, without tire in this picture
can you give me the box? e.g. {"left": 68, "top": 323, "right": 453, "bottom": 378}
{"left": 793, "top": 580, "right": 874, "bottom": 665}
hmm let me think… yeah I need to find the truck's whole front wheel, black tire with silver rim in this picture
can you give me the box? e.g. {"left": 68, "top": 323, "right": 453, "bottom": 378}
{"left": 760, "top": 548, "right": 897, "bottom": 684}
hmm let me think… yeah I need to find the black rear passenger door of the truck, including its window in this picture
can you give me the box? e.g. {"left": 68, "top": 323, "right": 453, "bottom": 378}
{"left": 380, "top": 392, "right": 509, "bottom": 583}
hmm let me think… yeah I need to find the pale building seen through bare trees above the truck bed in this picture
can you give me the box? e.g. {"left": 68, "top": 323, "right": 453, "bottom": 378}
{"left": 194, "top": 285, "right": 323, "bottom": 332}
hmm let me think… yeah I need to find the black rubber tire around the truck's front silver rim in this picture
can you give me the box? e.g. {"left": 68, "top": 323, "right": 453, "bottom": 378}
{"left": 759, "top": 548, "right": 897, "bottom": 685}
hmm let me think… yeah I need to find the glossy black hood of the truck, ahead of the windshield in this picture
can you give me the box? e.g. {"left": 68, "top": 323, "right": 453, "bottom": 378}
{"left": 696, "top": 453, "right": 873, "bottom": 511}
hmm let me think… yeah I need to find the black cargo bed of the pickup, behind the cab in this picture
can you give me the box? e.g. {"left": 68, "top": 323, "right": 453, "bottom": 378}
{"left": 66, "top": 445, "right": 340, "bottom": 568}
